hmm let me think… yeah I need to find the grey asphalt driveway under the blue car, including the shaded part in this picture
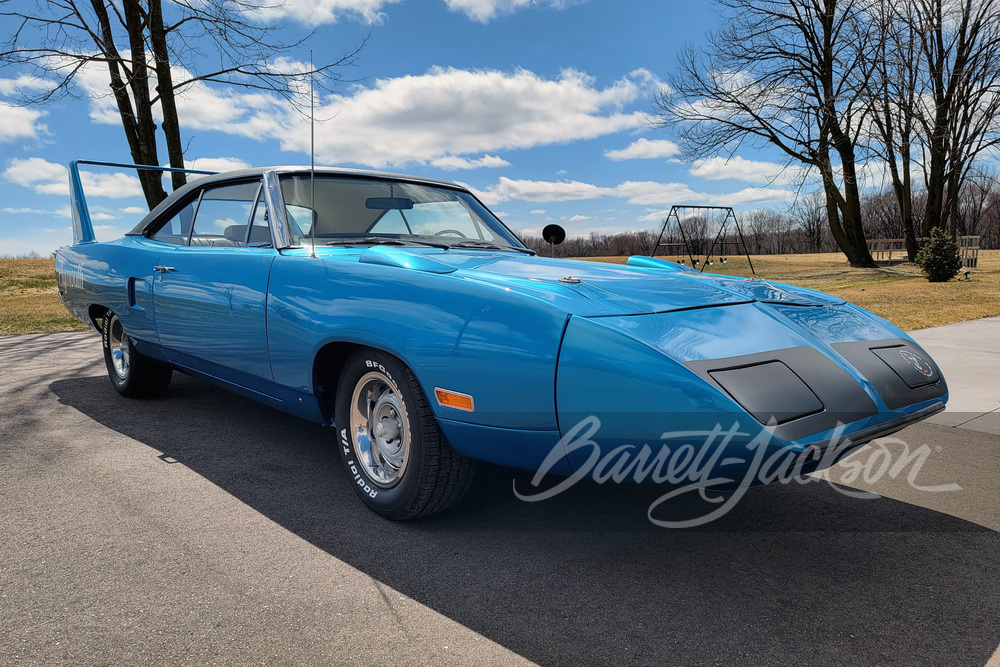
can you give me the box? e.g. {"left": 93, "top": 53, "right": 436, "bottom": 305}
{"left": 0, "top": 318, "right": 1000, "bottom": 665}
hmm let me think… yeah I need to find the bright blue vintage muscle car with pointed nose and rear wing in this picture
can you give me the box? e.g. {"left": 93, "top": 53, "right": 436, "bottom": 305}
{"left": 56, "top": 163, "right": 948, "bottom": 519}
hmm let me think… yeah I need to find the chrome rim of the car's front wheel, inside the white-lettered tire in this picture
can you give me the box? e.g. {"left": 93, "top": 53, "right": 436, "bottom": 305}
{"left": 351, "top": 371, "right": 410, "bottom": 488}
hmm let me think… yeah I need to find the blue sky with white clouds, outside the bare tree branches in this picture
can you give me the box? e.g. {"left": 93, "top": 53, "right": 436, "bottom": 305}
{"left": 0, "top": 0, "right": 796, "bottom": 256}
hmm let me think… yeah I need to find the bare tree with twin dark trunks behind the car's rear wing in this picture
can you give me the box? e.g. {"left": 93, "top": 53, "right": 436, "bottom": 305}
{"left": 0, "top": 0, "right": 364, "bottom": 208}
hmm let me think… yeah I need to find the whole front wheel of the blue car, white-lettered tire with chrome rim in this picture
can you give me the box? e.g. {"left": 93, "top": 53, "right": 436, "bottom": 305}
{"left": 335, "top": 350, "right": 475, "bottom": 519}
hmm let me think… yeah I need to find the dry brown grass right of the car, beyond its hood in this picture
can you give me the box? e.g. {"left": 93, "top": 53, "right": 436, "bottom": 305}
{"left": 595, "top": 250, "right": 1000, "bottom": 331}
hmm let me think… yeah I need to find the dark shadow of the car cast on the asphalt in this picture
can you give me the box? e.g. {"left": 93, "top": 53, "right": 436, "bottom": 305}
{"left": 50, "top": 375, "right": 1000, "bottom": 664}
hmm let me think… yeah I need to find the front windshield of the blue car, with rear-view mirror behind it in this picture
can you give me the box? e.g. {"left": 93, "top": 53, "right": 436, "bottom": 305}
{"left": 281, "top": 174, "right": 524, "bottom": 250}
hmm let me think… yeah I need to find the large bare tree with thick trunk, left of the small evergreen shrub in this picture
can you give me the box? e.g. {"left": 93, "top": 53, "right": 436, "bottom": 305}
{"left": 657, "top": 0, "right": 875, "bottom": 267}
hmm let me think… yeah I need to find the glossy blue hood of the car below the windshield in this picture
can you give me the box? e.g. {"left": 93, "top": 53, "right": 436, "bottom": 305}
{"left": 359, "top": 246, "right": 843, "bottom": 316}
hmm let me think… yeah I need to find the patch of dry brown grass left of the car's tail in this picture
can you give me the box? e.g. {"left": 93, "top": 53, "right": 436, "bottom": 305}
{"left": 0, "top": 259, "right": 87, "bottom": 336}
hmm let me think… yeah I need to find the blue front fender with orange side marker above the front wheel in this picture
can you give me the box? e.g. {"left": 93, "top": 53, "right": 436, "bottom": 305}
{"left": 267, "top": 255, "right": 566, "bottom": 431}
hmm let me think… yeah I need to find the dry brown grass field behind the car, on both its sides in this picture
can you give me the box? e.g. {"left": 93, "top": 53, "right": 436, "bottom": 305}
{"left": 0, "top": 250, "right": 1000, "bottom": 335}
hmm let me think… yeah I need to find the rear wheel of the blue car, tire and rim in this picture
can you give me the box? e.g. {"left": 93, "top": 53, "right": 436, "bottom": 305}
{"left": 101, "top": 310, "right": 173, "bottom": 398}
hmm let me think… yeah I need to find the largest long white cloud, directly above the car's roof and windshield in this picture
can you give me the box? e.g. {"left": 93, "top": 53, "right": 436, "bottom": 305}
{"left": 288, "top": 68, "right": 655, "bottom": 167}
